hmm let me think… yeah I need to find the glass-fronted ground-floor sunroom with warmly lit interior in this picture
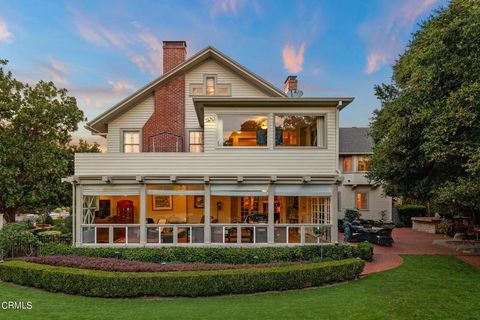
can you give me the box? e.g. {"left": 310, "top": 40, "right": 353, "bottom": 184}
{"left": 75, "top": 183, "right": 336, "bottom": 246}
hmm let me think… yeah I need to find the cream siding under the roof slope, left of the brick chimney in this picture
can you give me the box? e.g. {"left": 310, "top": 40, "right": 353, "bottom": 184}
{"left": 107, "top": 96, "right": 154, "bottom": 152}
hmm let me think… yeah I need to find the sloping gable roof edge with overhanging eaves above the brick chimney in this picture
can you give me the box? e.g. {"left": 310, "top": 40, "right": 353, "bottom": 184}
{"left": 85, "top": 46, "right": 286, "bottom": 134}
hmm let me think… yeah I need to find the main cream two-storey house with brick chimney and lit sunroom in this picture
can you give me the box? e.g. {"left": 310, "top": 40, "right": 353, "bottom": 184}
{"left": 70, "top": 41, "right": 353, "bottom": 246}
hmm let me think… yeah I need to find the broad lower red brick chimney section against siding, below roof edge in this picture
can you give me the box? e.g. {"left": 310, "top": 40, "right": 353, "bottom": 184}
{"left": 142, "top": 75, "right": 185, "bottom": 152}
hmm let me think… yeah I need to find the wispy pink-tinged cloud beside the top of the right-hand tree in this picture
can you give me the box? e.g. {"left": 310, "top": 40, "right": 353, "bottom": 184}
{"left": 360, "top": 0, "right": 441, "bottom": 74}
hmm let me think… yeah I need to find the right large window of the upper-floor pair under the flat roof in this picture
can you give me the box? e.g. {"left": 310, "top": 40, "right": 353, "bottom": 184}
{"left": 275, "top": 114, "right": 325, "bottom": 147}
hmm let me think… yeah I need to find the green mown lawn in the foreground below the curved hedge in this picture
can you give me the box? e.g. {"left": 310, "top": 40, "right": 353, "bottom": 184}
{"left": 0, "top": 256, "right": 480, "bottom": 320}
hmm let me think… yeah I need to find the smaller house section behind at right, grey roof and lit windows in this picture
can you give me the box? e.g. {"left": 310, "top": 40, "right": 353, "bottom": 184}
{"left": 337, "top": 128, "right": 392, "bottom": 222}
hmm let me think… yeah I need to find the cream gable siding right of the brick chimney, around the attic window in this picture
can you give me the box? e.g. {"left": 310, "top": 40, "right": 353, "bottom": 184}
{"left": 185, "top": 59, "right": 269, "bottom": 129}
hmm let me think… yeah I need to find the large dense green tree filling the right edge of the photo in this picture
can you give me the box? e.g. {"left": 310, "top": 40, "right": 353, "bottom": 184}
{"left": 369, "top": 0, "right": 480, "bottom": 222}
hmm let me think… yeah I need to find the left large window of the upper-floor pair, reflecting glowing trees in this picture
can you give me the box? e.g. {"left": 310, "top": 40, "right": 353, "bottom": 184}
{"left": 218, "top": 114, "right": 268, "bottom": 147}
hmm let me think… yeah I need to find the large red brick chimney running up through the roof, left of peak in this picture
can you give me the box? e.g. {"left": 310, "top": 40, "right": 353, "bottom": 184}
{"left": 142, "top": 41, "right": 187, "bottom": 152}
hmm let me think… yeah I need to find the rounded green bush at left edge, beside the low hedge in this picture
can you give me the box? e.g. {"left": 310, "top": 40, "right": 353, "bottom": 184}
{"left": 0, "top": 222, "right": 40, "bottom": 259}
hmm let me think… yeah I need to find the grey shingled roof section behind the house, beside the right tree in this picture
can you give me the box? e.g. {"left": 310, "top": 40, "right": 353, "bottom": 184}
{"left": 339, "top": 127, "right": 373, "bottom": 154}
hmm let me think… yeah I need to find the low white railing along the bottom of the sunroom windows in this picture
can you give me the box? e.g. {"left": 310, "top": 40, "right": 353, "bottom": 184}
{"left": 81, "top": 223, "right": 332, "bottom": 246}
